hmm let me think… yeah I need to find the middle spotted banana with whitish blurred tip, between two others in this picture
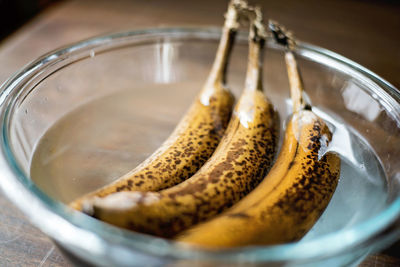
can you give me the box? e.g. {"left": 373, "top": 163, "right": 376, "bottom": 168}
{"left": 85, "top": 8, "right": 279, "bottom": 237}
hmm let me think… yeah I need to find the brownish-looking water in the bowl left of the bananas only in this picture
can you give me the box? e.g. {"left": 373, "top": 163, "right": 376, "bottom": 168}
{"left": 30, "top": 83, "right": 195, "bottom": 203}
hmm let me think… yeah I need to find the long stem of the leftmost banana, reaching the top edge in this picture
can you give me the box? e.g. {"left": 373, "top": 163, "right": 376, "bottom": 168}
{"left": 207, "top": 0, "right": 242, "bottom": 87}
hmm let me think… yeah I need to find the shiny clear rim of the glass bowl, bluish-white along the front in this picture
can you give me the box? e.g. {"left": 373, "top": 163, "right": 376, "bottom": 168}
{"left": 0, "top": 27, "right": 400, "bottom": 262}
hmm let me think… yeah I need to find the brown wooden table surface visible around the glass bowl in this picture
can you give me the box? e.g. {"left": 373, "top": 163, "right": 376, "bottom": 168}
{"left": 0, "top": 0, "right": 400, "bottom": 266}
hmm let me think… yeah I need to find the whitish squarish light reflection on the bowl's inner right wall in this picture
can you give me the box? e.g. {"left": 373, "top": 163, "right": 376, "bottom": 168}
{"left": 342, "top": 82, "right": 381, "bottom": 121}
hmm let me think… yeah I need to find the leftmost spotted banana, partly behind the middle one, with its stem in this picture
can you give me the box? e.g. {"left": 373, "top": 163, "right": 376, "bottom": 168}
{"left": 70, "top": 0, "right": 246, "bottom": 213}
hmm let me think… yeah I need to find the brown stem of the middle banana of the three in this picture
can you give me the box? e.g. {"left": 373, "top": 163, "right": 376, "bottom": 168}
{"left": 245, "top": 8, "right": 266, "bottom": 91}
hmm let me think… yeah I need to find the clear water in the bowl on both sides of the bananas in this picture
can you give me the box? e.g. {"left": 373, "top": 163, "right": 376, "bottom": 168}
{"left": 31, "top": 87, "right": 387, "bottom": 240}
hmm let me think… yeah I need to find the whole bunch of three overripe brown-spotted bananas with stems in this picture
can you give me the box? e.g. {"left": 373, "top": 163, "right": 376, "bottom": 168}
{"left": 71, "top": 0, "right": 340, "bottom": 247}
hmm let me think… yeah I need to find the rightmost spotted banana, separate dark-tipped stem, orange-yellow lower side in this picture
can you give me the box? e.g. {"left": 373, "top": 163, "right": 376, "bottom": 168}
{"left": 176, "top": 22, "right": 340, "bottom": 248}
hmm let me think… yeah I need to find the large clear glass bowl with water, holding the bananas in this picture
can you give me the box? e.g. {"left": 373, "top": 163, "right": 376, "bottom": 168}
{"left": 0, "top": 28, "right": 400, "bottom": 266}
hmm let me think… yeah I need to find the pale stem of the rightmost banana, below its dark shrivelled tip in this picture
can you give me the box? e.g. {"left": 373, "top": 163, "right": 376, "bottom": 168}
{"left": 285, "top": 50, "right": 305, "bottom": 113}
